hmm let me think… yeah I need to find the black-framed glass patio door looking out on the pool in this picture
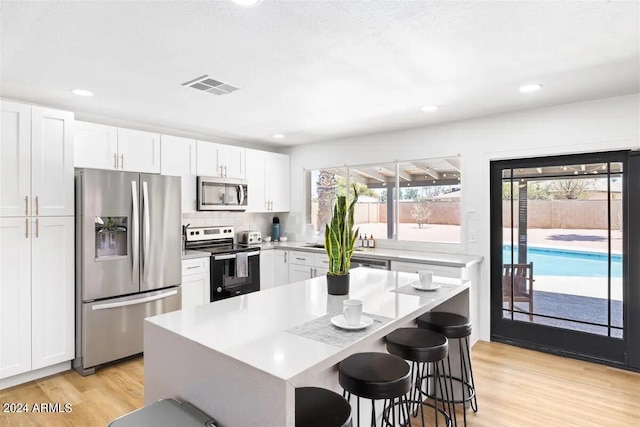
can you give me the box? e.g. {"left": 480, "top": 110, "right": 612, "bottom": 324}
{"left": 491, "top": 152, "right": 640, "bottom": 365}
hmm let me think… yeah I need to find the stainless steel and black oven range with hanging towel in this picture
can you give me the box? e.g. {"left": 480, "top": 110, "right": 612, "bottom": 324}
{"left": 186, "top": 226, "right": 260, "bottom": 301}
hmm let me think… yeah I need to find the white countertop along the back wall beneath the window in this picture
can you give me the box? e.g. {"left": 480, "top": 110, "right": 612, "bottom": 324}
{"left": 260, "top": 242, "right": 483, "bottom": 268}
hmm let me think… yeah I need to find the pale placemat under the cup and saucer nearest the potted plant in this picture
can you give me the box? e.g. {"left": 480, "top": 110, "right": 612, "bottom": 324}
{"left": 286, "top": 313, "right": 391, "bottom": 348}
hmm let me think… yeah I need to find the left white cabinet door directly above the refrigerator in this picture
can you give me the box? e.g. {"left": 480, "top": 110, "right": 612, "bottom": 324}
{"left": 74, "top": 121, "right": 120, "bottom": 169}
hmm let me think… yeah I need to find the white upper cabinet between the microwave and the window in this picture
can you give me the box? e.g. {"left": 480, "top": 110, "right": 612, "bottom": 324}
{"left": 247, "top": 149, "right": 291, "bottom": 212}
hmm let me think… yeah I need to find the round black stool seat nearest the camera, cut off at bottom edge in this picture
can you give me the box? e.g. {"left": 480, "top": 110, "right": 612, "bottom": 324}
{"left": 296, "top": 387, "right": 352, "bottom": 427}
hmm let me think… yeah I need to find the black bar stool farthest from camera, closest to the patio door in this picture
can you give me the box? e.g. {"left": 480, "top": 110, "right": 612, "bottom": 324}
{"left": 417, "top": 311, "right": 478, "bottom": 426}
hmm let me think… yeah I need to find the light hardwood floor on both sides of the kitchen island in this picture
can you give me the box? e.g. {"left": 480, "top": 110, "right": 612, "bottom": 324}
{"left": 0, "top": 342, "right": 640, "bottom": 427}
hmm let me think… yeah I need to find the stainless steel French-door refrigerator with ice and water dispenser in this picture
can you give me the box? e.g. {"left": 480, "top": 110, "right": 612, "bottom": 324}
{"left": 73, "top": 169, "right": 182, "bottom": 375}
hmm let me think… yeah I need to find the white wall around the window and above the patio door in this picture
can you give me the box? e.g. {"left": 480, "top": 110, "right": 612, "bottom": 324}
{"left": 291, "top": 94, "right": 640, "bottom": 340}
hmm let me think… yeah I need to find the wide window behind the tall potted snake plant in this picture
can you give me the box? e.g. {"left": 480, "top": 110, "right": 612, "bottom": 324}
{"left": 309, "top": 157, "right": 462, "bottom": 243}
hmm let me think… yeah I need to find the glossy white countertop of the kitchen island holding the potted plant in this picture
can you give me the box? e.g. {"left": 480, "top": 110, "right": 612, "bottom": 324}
{"left": 146, "top": 268, "right": 469, "bottom": 383}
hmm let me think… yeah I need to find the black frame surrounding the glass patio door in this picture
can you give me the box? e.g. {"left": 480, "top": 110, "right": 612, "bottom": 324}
{"left": 490, "top": 150, "right": 640, "bottom": 369}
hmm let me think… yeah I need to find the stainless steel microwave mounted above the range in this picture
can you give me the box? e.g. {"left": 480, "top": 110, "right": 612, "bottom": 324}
{"left": 197, "top": 176, "right": 248, "bottom": 211}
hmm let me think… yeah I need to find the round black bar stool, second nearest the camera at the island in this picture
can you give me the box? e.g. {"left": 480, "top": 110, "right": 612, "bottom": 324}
{"left": 338, "top": 353, "right": 411, "bottom": 427}
